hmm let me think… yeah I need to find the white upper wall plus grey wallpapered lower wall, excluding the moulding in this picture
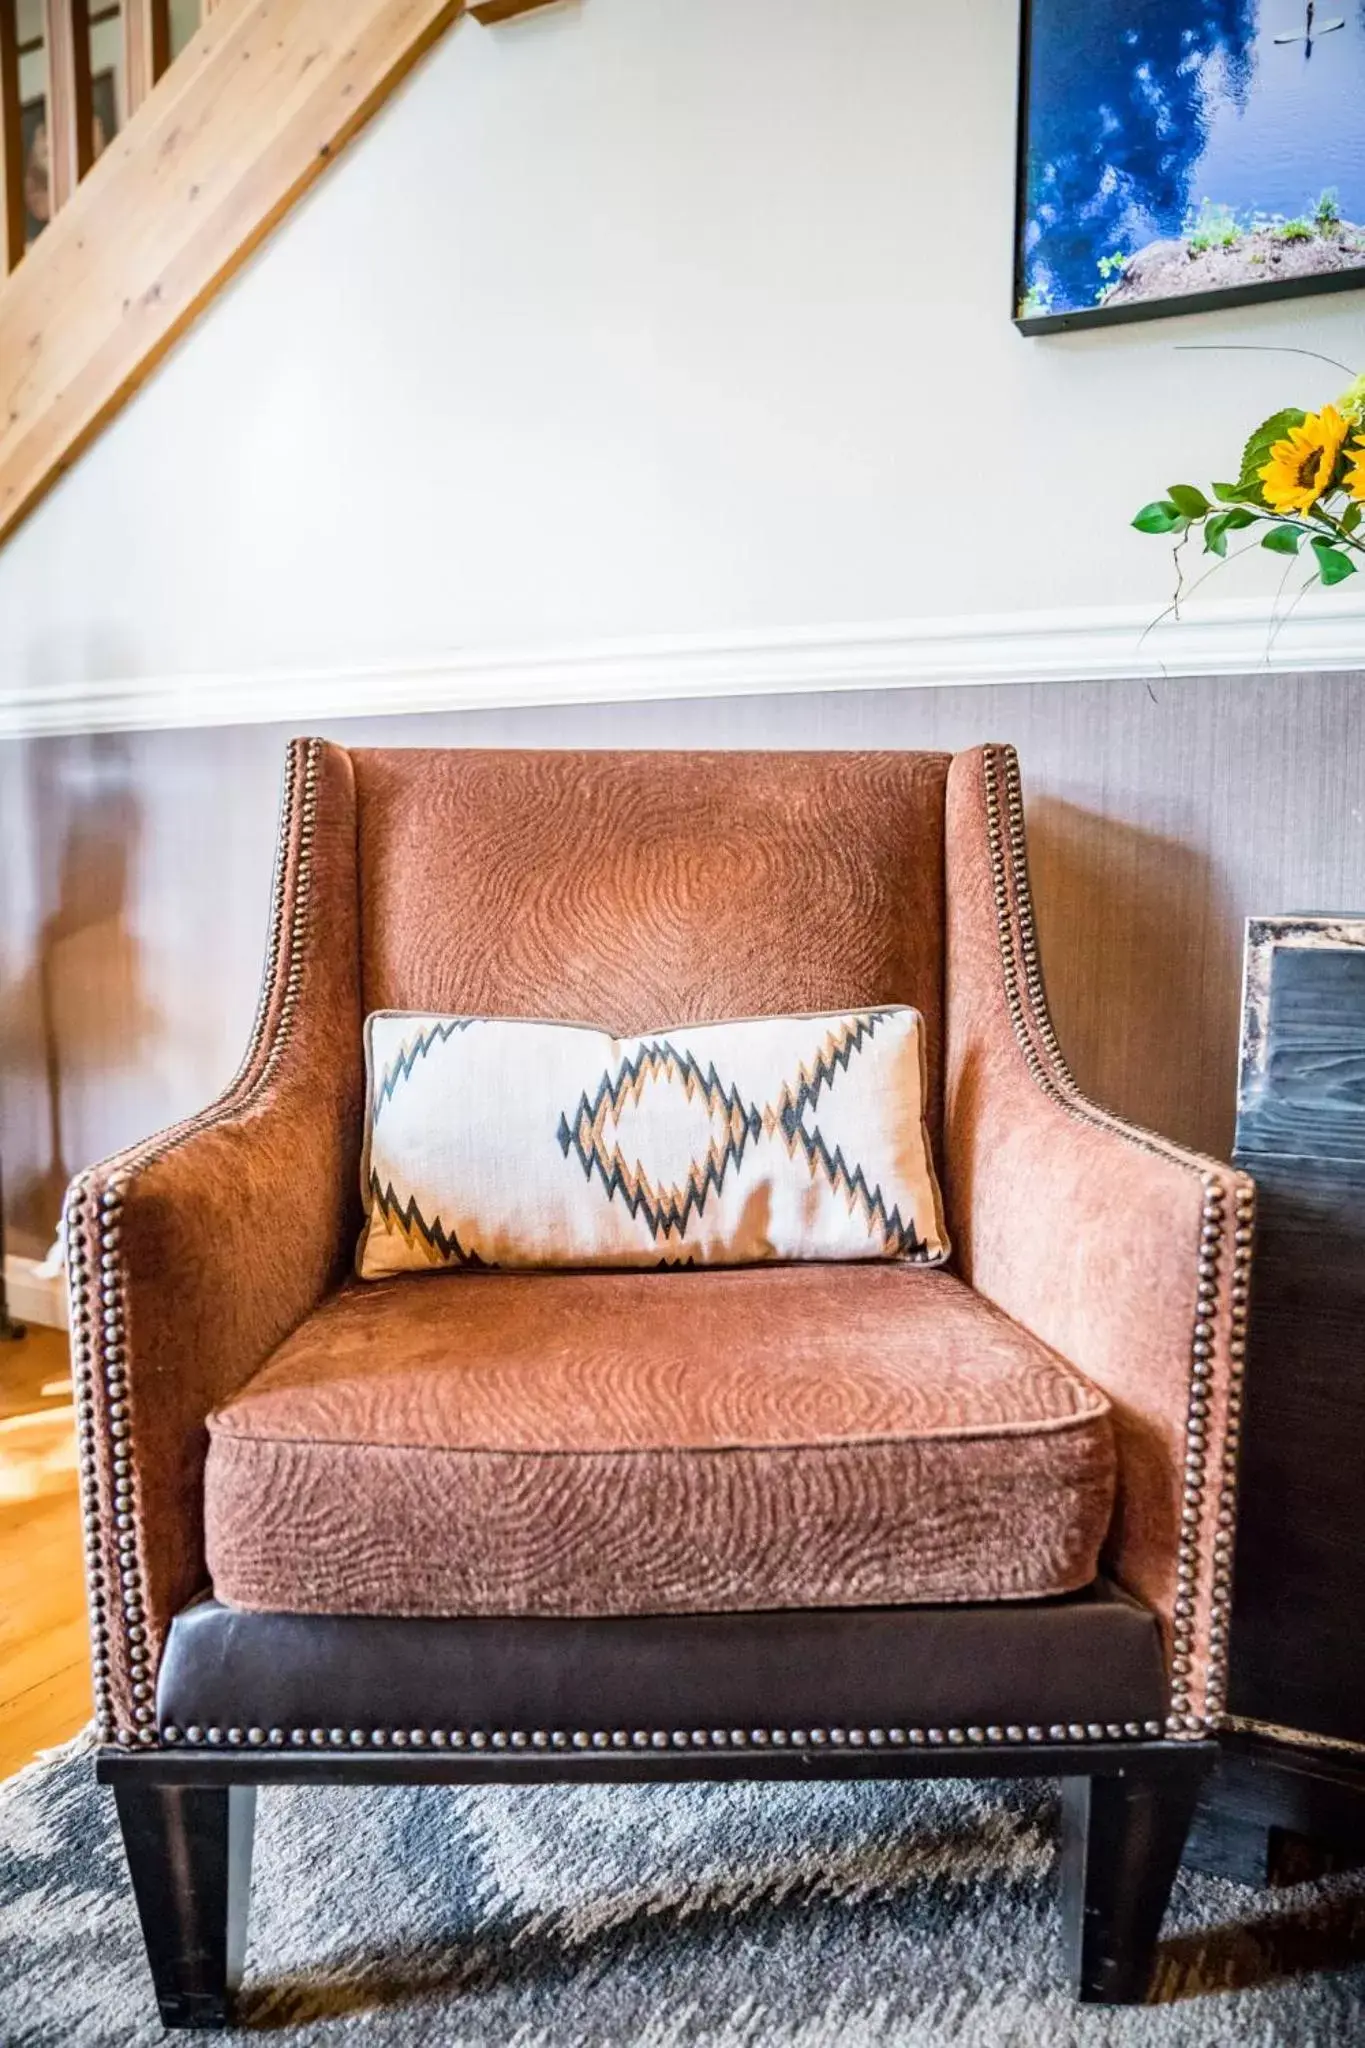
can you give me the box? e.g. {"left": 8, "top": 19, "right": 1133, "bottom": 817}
{"left": 0, "top": 0, "right": 1365, "bottom": 1249}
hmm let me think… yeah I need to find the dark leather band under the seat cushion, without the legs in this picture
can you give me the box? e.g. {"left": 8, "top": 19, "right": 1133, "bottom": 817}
{"left": 156, "top": 1581, "right": 1166, "bottom": 1749}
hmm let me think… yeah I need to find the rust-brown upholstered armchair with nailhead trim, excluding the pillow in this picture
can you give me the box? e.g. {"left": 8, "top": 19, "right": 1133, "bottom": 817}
{"left": 68, "top": 741, "right": 1252, "bottom": 2025}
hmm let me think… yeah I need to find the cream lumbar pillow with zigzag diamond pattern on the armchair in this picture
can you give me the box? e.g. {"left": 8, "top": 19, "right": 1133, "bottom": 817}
{"left": 356, "top": 1008, "right": 948, "bottom": 1280}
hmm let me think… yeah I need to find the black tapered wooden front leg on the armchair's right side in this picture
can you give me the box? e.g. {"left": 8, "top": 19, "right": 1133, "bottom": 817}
{"left": 1062, "top": 1753, "right": 1207, "bottom": 2005}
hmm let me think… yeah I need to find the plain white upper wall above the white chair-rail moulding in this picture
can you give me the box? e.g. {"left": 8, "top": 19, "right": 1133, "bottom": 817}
{"left": 0, "top": 0, "right": 1365, "bottom": 690}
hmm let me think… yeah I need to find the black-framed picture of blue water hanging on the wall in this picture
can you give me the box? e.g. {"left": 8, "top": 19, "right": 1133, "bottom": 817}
{"left": 1013, "top": 0, "right": 1365, "bottom": 334}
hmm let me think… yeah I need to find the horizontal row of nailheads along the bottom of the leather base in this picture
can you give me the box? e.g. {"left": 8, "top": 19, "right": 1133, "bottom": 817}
{"left": 162, "top": 1720, "right": 1166, "bottom": 1753}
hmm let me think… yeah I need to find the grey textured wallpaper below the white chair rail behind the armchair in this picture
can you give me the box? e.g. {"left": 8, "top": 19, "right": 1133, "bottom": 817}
{"left": 0, "top": 674, "right": 1365, "bottom": 1251}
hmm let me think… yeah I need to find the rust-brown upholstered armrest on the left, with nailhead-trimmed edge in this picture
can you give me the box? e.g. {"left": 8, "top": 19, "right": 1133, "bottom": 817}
{"left": 65, "top": 741, "right": 362, "bottom": 1745}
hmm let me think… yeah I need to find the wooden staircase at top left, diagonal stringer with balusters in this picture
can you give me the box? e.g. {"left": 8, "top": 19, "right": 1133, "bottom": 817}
{"left": 0, "top": 0, "right": 560, "bottom": 539}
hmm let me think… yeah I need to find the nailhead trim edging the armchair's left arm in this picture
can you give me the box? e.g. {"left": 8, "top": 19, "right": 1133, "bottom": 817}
{"left": 65, "top": 739, "right": 319, "bottom": 1749}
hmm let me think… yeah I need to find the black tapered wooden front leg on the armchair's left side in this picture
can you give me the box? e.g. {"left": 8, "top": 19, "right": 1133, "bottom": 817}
{"left": 115, "top": 1780, "right": 256, "bottom": 2028}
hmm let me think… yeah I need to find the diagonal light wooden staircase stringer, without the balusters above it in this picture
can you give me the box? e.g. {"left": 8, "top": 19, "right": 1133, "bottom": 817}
{"left": 0, "top": 0, "right": 460, "bottom": 539}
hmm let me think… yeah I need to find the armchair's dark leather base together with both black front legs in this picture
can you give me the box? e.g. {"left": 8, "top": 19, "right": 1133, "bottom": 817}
{"left": 127, "top": 1583, "right": 1216, "bottom": 2028}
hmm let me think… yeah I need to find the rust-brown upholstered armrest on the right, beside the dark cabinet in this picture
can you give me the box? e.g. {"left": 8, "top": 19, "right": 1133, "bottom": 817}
{"left": 943, "top": 748, "right": 1254, "bottom": 1735}
